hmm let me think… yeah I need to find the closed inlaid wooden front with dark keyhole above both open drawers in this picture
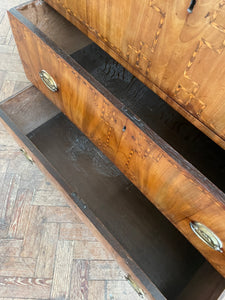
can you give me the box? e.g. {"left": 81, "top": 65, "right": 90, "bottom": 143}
{"left": 46, "top": 0, "right": 225, "bottom": 149}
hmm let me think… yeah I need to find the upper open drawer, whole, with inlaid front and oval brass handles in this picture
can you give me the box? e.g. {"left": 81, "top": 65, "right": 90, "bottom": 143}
{"left": 9, "top": 1, "right": 225, "bottom": 276}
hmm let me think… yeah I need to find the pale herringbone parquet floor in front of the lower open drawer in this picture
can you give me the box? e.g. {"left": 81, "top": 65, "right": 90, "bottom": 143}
{"left": 0, "top": 102, "right": 142, "bottom": 300}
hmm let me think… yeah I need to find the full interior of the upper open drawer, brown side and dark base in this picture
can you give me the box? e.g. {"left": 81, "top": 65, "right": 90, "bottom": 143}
{"left": 18, "top": 1, "right": 225, "bottom": 192}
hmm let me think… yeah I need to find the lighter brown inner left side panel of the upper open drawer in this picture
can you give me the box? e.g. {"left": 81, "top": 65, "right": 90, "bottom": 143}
{"left": 18, "top": 1, "right": 91, "bottom": 53}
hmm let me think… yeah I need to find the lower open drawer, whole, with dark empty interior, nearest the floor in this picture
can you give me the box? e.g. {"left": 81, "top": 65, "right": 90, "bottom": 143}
{"left": 0, "top": 86, "right": 225, "bottom": 300}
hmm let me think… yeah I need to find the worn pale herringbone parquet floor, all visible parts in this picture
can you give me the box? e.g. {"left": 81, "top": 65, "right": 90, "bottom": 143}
{"left": 0, "top": 0, "right": 139, "bottom": 300}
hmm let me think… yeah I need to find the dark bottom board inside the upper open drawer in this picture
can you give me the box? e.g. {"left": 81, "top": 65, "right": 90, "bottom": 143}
{"left": 72, "top": 43, "right": 225, "bottom": 192}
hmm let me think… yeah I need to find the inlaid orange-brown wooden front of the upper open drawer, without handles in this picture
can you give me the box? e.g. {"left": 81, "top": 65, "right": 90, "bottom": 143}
{"left": 9, "top": 5, "right": 225, "bottom": 276}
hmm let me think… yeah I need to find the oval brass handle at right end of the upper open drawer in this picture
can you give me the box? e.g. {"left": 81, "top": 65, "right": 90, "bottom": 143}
{"left": 190, "top": 222, "right": 223, "bottom": 252}
